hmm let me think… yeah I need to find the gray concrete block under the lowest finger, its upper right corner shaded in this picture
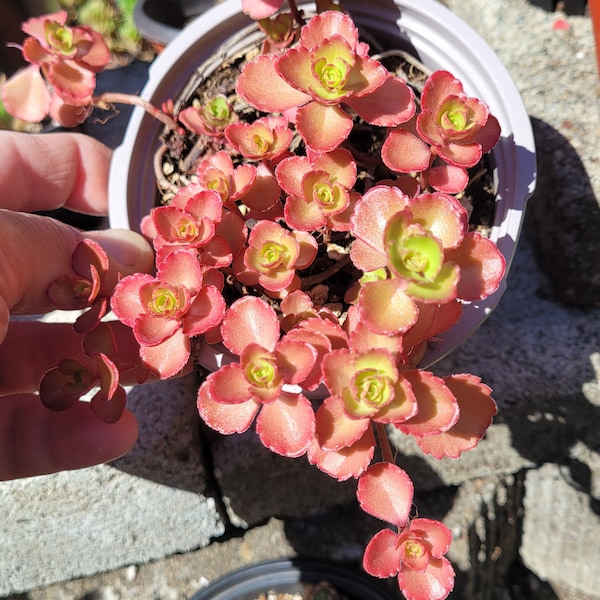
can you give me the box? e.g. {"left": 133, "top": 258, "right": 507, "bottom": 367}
{"left": 0, "top": 377, "right": 224, "bottom": 595}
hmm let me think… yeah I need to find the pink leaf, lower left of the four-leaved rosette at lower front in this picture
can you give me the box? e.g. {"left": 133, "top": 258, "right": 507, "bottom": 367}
{"left": 197, "top": 381, "right": 260, "bottom": 435}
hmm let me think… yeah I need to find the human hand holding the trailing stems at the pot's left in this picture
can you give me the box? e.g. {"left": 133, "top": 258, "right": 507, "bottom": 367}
{"left": 0, "top": 132, "right": 154, "bottom": 480}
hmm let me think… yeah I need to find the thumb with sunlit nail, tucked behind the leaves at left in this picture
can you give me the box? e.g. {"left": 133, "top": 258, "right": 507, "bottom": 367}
{"left": 0, "top": 209, "right": 154, "bottom": 342}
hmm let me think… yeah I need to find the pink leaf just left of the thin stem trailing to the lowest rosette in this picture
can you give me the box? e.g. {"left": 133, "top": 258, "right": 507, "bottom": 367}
{"left": 308, "top": 427, "right": 375, "bottom": 481}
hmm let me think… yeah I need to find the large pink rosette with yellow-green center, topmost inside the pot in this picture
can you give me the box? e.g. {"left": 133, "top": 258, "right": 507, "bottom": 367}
{"left": 236, "top": 11, "right": 415, "bottom": 152}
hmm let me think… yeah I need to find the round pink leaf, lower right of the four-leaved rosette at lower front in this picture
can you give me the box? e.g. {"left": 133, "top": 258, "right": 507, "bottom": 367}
{"left": 256, "top": 392, "right": 315, "bottom": 458}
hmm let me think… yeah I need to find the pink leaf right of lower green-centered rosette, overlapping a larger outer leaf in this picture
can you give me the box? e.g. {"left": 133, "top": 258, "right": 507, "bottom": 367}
{"left": 395, "top": 370, "right": 460, "bottom": 438}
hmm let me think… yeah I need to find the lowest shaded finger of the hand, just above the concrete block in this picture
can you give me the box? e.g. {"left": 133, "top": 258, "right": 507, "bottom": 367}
{"left": 0, "top": 394, "right": 138, "bottom": 481}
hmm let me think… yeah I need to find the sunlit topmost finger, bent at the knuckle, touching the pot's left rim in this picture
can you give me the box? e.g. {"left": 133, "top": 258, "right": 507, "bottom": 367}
{"left": 0, "top": 131, "right": 111, "bottom": 215}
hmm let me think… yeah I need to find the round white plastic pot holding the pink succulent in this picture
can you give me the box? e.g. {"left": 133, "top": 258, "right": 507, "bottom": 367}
{"left": 109, "top": 0, "right": 536, "bottom": 368}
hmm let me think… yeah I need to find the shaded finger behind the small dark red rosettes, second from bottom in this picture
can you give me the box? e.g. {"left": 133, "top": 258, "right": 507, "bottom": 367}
{"left": 0, "top": 321, "right": 145, "bottom": 402}
